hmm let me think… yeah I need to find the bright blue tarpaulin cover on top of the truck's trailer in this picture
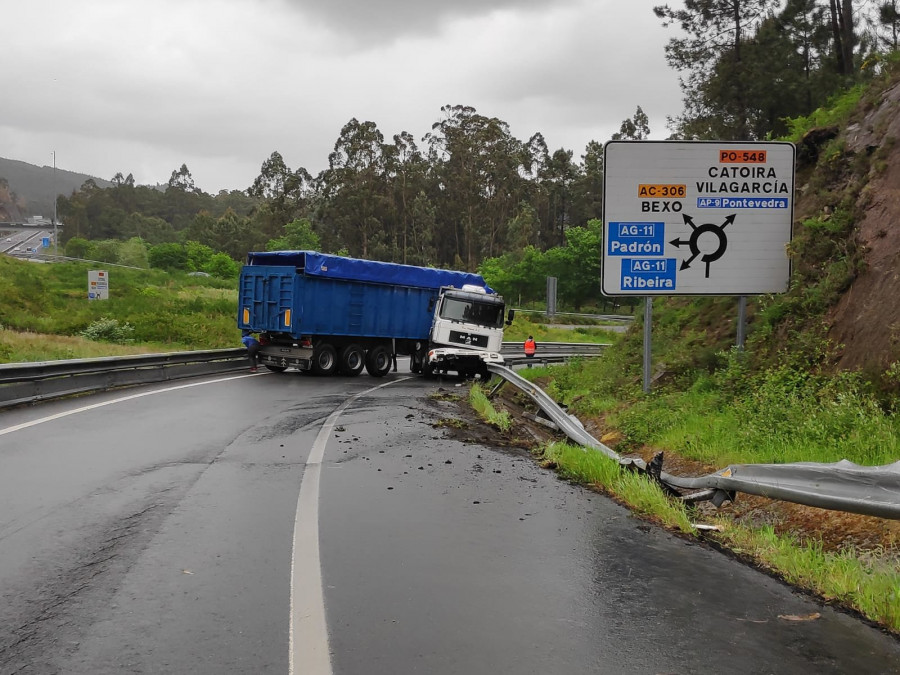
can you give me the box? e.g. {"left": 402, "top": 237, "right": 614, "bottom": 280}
{"left": 247, "top": 251, "right": 494, "bottom": 293}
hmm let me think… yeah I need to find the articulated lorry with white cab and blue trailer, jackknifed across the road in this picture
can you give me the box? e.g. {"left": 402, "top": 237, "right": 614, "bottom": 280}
{"left": 237, "top": 251, "right": 513, "bottom": 377}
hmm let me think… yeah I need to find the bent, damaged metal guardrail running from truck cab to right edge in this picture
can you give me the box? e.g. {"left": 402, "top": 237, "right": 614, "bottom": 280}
{"left": 488, "top": 365, "right": 900, "bottom": 520}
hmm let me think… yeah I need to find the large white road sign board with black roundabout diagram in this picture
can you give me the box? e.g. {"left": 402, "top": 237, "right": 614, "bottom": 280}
{"left": 601, "top": 141, "right": 795, "bottom": 295}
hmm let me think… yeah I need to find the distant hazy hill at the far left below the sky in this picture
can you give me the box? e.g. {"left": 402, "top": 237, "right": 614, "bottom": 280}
{"left": 0, "top": 157, "right": 112, "bottom": 220}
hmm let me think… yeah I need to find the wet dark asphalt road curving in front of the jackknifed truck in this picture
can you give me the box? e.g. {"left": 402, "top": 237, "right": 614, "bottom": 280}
{"left": 0, "top": 373, "right": 900, "bottom": 675}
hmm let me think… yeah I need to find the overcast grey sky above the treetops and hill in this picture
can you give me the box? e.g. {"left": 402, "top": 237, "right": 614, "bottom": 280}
{"left": 0, "top": 0, "right": 682, "bottom": 194}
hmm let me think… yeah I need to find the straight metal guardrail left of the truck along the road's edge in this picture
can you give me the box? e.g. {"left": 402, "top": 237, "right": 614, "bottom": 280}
{"left": 0, "top": 348, "right": 247, "bottom": 409}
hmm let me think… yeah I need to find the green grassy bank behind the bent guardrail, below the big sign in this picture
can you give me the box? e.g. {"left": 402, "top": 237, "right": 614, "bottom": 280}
{"left": 521, "top": 344, "right": 900, "bottom": 466}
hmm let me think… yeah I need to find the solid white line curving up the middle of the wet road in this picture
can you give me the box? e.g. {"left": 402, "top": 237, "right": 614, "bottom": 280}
{"left": 288, "top": 377, "right": 410, "bottom": 675}
